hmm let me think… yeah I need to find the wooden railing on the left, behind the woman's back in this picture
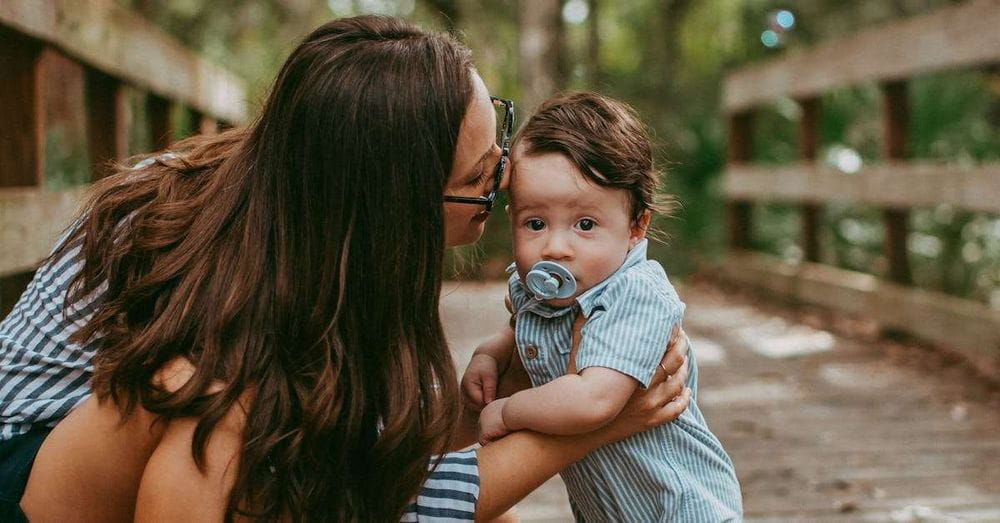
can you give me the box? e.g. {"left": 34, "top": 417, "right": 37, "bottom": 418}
{"left": 0, "top": 0, "right": 246, "bottom": 317}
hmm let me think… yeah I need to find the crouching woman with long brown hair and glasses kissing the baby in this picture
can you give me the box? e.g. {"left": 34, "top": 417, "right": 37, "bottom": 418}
{"left": 0, "top": 17, "right": 687, "bottom": 521}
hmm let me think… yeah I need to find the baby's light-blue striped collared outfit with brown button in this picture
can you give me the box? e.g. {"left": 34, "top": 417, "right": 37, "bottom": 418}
{"left": 508, "top": 240, "right": 743, "bottom": 522}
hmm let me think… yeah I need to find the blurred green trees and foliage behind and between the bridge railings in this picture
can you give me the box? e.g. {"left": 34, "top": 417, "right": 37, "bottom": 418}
{"left": 35, "top": 0, "right": 1000, "bottom": 307}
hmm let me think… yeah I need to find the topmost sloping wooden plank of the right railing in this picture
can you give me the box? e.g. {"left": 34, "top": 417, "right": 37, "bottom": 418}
{"left": 723, "top": 0, "right": 1000, "bottom": 113}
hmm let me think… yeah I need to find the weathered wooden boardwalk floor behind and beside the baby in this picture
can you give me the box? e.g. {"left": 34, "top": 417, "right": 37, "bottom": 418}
{"left": 442, "top": 282, "right": 1000, "bottom": 521}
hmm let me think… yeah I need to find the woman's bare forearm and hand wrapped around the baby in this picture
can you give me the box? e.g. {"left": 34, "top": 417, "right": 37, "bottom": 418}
{"left": 476, "top": 330, "right": 691, "bottom": 521}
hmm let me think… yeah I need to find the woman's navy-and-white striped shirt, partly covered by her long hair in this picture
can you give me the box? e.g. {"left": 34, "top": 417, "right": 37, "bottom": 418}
{"left": 0, "top": 216, "right": 479, "bottom": 522}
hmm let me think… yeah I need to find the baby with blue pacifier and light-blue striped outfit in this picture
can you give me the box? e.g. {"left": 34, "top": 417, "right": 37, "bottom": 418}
{"left": 462, "top": 93, "right": 742, "bottom": 521}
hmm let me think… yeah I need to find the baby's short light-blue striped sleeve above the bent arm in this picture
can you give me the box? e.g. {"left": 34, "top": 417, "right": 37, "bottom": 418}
{"left": 576, "top": 274, "right": 684, "bottom": 388}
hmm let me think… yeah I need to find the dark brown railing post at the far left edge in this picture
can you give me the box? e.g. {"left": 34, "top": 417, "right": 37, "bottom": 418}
{"left": 0, "top": 28, "right": 45, "bottom": 318}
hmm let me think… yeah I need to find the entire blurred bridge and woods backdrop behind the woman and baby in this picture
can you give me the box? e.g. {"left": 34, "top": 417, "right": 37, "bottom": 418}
{"left": 7, "top": 0, "right": 1000, "bottom": 521}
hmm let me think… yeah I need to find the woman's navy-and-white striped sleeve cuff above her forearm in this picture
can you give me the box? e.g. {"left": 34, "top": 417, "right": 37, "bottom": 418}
{"left": 400, "top": 450, "right": 479, "bottom": 522}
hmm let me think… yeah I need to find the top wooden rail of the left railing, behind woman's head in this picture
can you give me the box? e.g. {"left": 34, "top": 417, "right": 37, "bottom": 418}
{"left": 0, "top": 0, "right": 246, "bottom": 123}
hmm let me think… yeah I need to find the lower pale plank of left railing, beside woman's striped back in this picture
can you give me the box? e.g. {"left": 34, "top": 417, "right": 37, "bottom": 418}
{"left": 0, "top": 187, "right": 86, "bottom": 276}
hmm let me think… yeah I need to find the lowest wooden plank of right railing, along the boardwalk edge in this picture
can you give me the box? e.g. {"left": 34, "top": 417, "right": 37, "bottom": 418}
{"left": 722, "top": 251, "right": 1000, "bottom": 377}
